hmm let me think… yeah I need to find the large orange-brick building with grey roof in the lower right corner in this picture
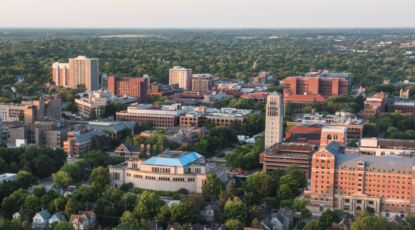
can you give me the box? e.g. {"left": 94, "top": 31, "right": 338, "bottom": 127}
{"left": 304, "top": 142, "right": 415, "bottom": 217}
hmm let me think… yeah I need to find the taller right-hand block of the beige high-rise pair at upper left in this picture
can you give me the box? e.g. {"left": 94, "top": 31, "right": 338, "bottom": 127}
{"left": 68, "top": 56, "right": 99, "bottom": 91}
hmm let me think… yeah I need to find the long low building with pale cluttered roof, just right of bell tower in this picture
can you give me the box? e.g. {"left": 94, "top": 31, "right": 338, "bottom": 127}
{"left": 287, "top": 112, "right": 368, "bottom": 140}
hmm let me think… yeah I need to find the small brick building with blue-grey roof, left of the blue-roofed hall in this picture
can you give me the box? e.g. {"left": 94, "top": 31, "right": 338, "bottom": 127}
{"left": 63, "top": 131, "right": 108, "bottom": 157}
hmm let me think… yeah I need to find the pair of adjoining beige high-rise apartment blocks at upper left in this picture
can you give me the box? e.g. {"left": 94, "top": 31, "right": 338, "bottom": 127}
{"left": 52, "top": 56, "right": 99, "bottom": 91}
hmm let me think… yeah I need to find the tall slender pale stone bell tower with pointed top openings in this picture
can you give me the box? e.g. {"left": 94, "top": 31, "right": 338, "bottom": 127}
{"left": 265, "top": 91, "right": 283, "bottom": 149}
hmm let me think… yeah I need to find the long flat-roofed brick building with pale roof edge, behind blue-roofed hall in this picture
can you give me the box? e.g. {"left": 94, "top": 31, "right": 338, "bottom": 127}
{"left": 117, "top": 104, "right": 193, "bottom": 127}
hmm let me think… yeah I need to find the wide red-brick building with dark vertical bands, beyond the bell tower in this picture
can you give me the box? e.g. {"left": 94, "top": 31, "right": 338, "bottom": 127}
{"left": 283, "top": 77, "right": 349, "bottom": 97}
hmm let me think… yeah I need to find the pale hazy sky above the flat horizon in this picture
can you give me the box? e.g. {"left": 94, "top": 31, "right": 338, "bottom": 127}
{"left": 0, "top": 0, "right": 415, "bottom": 28}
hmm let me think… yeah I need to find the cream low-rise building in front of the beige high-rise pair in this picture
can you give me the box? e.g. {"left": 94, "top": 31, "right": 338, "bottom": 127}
{"left": 75, "top": 90, "right": 137, "bottom": 117}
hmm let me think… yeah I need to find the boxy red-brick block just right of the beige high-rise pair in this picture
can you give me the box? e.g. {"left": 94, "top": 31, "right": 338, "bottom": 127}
{"left": 107, "top": 76, "right": 149, "bottom": 103}
